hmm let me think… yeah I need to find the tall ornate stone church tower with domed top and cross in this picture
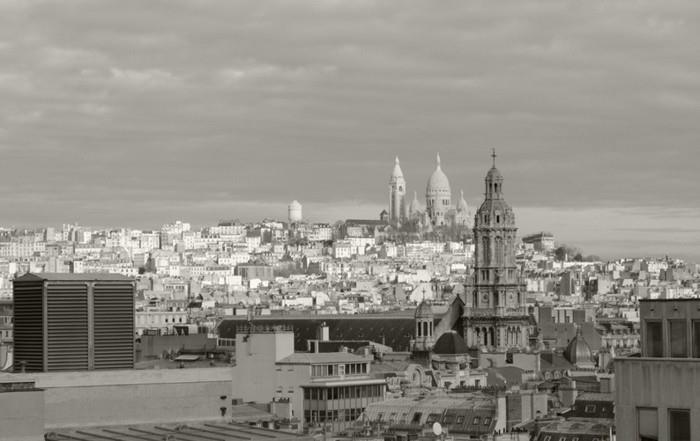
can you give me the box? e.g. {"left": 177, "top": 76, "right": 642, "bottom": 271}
{"left": 462, "top": 151, "right": 533, "bottom": 350}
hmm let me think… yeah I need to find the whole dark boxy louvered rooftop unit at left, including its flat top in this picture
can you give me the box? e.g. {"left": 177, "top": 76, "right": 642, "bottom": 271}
{"left": 13, "top": 273, "right": 134, "bottom": 372}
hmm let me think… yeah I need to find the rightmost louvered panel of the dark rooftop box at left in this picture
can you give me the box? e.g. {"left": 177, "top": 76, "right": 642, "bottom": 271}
{"left": 93, "top": 283, "right": 134, "bottom": 369}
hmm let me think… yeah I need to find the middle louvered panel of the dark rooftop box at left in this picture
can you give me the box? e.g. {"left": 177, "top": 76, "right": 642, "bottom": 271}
{"left": 46, "top": 283, "right": 88, "bottom": 371}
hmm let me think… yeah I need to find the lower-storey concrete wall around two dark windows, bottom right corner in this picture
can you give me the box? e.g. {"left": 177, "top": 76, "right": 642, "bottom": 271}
{"left": 615, "top": 358, "right": 700, "bottom": 441}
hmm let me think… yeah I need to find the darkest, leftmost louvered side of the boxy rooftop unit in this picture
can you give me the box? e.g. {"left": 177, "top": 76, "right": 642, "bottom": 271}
{"left": 13, "top": 281, "right": 44, "bottom": 372}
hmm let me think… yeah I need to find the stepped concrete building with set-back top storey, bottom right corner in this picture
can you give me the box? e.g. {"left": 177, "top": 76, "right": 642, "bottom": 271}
{"left": 614, "top": 299, "right": 700, "bottom": 440}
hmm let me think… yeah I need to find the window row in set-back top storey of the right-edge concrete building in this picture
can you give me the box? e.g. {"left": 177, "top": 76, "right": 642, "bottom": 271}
{"left": 645, "top": 319, "right": 700, "bottom": 358}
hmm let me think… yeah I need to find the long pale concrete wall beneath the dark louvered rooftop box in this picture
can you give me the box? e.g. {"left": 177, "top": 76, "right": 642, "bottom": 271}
{"left": 0, "top": 368, "right": 232, "bottom": 428}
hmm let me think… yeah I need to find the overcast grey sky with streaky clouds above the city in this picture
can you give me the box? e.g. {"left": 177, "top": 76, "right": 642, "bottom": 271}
{"left": 0, "top": 0, "right": 700, "bottom": 258}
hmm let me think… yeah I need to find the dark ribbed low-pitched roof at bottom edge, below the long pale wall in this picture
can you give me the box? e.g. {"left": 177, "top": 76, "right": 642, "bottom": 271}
{"left": 45, "top": 421, "right": 313, "bottom": 441}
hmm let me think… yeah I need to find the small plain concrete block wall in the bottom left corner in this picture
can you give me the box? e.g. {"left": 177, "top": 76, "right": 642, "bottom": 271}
{"left": 0, "top": 390, "right": 44, "bottom": 441}
